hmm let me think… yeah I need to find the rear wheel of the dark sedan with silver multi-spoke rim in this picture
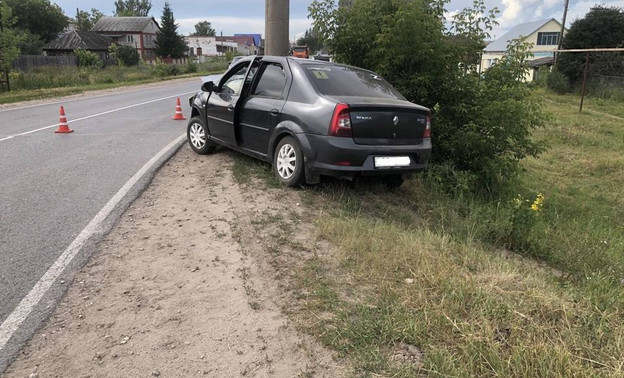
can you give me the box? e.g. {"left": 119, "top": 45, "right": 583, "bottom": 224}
{"left": 273, "top": 136, "right": 305, "bottom": 188}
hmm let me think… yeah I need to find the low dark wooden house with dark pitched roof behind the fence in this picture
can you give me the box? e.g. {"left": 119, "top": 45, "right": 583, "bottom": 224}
{"left": 43, "top": 30, "right": 114, "bottom": 60}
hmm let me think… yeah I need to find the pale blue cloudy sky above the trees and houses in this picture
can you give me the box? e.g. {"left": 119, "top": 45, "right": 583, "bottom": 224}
{"left": 51, "top": 0, "right": 624, "bottom": 39}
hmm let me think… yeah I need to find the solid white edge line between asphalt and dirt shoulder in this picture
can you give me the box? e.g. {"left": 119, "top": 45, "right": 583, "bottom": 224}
{"left": 0, "top": 133, "right": 186, "bottom": 350}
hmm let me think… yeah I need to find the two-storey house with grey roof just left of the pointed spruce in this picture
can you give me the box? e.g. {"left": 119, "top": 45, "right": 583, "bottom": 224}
{"left": 91, "top": 17, "right": 160, "bottom": 59}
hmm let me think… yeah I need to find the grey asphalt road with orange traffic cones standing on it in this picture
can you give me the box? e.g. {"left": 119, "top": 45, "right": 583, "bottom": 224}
{"left": 0, "top": 78, "right": 201, "bottom": 373}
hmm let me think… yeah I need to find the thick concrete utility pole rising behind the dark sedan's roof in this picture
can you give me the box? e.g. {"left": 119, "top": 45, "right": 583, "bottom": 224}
{"left": 264, "top": 0, "right": 290, "bottom": 56}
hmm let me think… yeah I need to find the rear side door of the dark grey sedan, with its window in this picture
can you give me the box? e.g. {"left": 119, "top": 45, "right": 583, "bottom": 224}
{"left": 238, "top": 59, "right": 292, "bottom": 156}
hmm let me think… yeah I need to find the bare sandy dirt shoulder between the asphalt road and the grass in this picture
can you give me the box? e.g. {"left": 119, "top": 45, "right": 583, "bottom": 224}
{"left": 6, "top": 146, "right": 345, "bottom": 377}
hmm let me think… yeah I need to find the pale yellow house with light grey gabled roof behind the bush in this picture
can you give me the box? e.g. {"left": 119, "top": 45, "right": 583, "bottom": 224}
{"left": 480, "top": 18, "right": 561, "bottom": 81}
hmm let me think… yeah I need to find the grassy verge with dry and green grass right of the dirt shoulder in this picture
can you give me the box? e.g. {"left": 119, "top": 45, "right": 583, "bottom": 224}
{"left": 234, "top": 94, "right": 624, "bottom": 377}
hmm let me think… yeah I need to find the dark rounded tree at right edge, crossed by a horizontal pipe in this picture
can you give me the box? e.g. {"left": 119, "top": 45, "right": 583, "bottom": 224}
{"left": 557, "top": 5, "right": 624, "bottom": 84}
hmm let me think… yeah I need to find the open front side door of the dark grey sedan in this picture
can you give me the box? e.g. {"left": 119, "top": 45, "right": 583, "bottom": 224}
{"left": 206, "top": 61, "right": 253, "bottom": 145}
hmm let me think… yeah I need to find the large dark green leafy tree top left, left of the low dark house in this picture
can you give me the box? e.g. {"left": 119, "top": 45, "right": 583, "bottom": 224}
{"left": 5, "top": 0, "right": 69, "bottom": 44}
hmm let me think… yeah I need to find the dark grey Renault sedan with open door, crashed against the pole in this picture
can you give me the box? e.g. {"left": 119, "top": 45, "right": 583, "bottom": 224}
{"left": 187, "top": 56, "right": 431, "bottom": 187}
